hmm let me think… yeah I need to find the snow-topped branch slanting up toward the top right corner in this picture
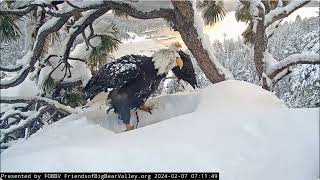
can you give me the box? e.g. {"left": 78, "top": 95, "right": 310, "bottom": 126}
{"left": 264, "top": 0, "right": 310, "bottom": 27}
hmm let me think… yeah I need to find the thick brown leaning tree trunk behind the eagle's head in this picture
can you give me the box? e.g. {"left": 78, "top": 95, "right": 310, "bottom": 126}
{"left": 171, "top": 1, "right": 227, "bottom": 83}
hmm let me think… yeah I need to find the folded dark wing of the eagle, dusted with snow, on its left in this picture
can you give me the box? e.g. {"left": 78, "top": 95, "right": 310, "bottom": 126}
{"left": 84, "top": 55, "right": 141, "bottom": 99}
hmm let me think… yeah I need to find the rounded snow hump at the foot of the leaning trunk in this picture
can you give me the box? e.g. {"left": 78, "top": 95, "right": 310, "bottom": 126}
{"left": 197, "top": 80, "right": 287, "bottom": 111}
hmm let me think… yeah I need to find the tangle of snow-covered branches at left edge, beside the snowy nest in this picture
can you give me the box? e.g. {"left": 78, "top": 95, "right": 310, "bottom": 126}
{"left": 0, "top": 96, "right": 80, "bottom": 144}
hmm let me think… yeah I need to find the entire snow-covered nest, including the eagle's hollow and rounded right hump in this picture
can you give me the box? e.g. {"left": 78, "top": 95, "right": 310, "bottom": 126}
{"left": 1, "top": 80, "right": 319, "bottom": 180}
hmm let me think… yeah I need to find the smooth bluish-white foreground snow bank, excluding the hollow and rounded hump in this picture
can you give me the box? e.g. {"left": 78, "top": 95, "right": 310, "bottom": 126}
{"left": 1, "top": 109, "right": 319, "bottom": 180}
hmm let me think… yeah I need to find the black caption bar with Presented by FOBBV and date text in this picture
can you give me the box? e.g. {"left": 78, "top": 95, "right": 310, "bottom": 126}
{"left": 0, "top": 172, "right": 219, "bottom": 180}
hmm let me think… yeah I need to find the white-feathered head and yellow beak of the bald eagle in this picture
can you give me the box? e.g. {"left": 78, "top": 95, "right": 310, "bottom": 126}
{"left": 152, "top": 42, "right": 183, "bottom": 74}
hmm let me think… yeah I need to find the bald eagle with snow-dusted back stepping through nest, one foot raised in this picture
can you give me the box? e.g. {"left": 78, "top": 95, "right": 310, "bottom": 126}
{"left": 84, "top": 43, "right": 183, "bottom": 130}
